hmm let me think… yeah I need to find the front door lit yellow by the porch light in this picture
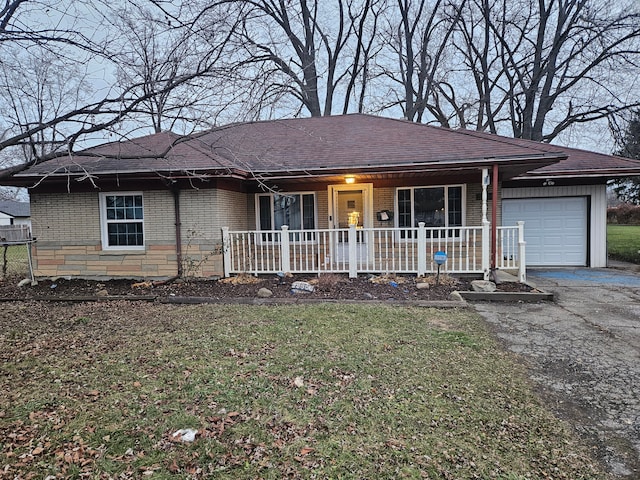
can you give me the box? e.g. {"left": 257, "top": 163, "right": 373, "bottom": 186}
{"left": 329, "top": 183, "right": 373, "bottom": 262}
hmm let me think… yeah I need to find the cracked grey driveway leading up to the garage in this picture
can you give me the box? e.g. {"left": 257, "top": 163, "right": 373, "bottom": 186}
{"left": 475, "top": 269, "right": 640, "bottom": 479}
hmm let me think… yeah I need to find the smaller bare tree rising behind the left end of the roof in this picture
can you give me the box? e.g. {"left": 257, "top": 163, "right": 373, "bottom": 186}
{"left": 114, "top": 5, "right": 238, "bottom": 133}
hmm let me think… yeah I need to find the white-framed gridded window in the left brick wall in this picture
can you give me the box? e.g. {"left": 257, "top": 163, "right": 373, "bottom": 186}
{"left": 100, "top": 193, "right": 144, "bottom": 250}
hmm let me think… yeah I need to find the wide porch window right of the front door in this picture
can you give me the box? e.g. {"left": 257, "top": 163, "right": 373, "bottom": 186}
{"left": 396, "top": 185, "right": 464, "bottom": 238}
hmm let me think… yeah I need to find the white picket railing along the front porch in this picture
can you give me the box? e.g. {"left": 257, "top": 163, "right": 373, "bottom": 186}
{"left": 222, "top": 223, "right": 525, "bottom": 281}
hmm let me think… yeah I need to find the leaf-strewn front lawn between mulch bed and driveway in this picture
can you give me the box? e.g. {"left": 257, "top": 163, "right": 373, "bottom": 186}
{"left": 0, "top": 302, "right": 606, "bottom": 480}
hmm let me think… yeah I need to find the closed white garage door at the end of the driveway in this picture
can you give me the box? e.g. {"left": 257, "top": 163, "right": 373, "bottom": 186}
{"left": 502, "top": 197, "right": 588, "bottom": 266}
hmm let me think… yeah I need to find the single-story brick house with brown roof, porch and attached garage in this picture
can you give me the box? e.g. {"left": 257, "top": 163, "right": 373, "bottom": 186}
{"left": 3, "top": 114, "right": 640, "bottom": 278}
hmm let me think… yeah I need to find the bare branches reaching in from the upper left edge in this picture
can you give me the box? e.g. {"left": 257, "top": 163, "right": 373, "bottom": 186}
{"left": 0, "top": 0, "right": 235, "bottom": 175}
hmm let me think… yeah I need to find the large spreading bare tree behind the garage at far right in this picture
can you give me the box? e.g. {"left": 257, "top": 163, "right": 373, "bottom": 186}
{"left": 452, "top": 0, "right": 640, "bottom": 141}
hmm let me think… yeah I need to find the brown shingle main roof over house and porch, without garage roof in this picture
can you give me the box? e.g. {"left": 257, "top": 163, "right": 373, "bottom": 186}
{"left": 6, "top": 114, "right": 564, "bottom": 183}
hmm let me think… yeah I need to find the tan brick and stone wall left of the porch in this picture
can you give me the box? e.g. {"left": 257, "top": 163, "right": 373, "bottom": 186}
{"left": 31, "top": 189, "right": 249, "bottom": 279}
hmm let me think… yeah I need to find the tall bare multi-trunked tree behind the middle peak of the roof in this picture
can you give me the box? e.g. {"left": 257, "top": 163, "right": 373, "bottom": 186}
{"left": 215, "top": 0, "right": 383, "bottom": 116}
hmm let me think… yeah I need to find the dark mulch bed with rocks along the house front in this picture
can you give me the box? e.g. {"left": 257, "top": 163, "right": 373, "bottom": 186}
{"left": 0, "top": 274, "right": 530, "bottom": 301}
